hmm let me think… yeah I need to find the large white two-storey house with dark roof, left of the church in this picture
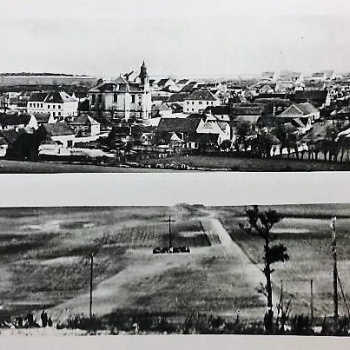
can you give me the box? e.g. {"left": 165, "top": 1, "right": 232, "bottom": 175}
{"left": 27, "top": 91, "right": 79, "bottom": 120}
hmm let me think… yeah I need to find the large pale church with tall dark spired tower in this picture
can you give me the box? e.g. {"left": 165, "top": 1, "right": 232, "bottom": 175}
{"left": 89, "top": 62, "right": 152, "bottom": 120}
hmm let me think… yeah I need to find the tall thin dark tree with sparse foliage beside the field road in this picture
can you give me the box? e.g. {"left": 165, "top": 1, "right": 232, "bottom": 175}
{"left": 245, "top": 205, "right": 289, "bottom": 333}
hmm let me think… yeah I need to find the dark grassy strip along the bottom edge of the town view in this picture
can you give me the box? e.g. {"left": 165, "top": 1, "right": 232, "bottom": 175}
{"left": 0, "top": 155, "right": 350, "bottom": 174}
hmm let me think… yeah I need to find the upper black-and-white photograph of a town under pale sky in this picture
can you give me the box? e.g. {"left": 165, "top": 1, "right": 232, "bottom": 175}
{"left": 0, "top": 0, "right": 350, "bottom": 173}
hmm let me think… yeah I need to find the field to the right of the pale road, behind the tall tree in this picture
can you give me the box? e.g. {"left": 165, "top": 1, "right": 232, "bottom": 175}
{"left": 219, "top": 204, "right": 350, "bottom": 317}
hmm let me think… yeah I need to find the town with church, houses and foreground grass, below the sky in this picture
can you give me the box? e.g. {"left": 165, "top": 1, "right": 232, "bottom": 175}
{"left": 0, "top": 62, "right": 350, "bottom": 172}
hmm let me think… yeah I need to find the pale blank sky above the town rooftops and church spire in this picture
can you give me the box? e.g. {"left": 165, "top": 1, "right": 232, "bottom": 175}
{"left": 0, "top": 0, "right": 350, "bottom": 77}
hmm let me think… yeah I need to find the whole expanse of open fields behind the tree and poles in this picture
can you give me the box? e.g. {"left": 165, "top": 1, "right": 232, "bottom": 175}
{"left": 0, "top": 205, "right": 350, "bottom": 328}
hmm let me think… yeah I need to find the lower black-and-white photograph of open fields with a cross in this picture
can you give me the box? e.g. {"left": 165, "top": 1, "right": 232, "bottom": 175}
{"left": 0, "top": 204, "right": 350, "bottom": 336}
